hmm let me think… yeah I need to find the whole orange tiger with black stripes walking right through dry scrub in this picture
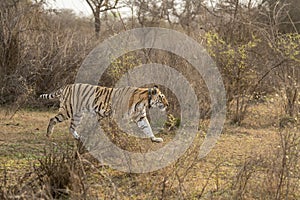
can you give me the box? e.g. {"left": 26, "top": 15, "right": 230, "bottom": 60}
{"left": 40, "top": 83, "right": 169, "bottom": 143}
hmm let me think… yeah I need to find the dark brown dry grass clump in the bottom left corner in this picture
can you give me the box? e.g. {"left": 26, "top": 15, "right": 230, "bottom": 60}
{"left": 0, "top": 143, "right": 93, "bottom": 199}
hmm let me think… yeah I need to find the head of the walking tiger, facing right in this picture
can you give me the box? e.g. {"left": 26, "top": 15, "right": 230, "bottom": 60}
{"left": 148, "top": 85, "right": 169, "bottom": 111}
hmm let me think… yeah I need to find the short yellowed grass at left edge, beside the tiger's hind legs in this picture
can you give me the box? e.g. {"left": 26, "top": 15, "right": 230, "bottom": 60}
{"left": 0, "top": 108, "right": 71, "bottom": 184}
